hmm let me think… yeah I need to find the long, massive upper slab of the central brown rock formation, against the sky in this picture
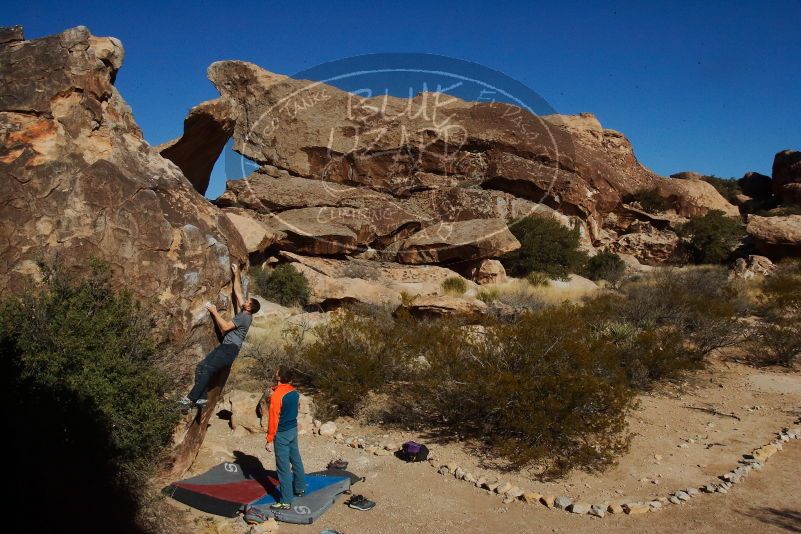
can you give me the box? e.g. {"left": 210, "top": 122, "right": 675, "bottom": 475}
{"left": 202, "top": 61, "right": 656, "bottom": 232}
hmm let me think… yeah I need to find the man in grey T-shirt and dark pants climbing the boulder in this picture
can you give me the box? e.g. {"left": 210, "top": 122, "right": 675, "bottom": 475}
{"left": 178, "top": 264, "right": 260, "bottom": 409}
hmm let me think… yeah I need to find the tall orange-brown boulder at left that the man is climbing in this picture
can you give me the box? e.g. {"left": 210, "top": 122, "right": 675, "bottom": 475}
{"left": 0, "top": 26, "right": 246, "bottom": 478}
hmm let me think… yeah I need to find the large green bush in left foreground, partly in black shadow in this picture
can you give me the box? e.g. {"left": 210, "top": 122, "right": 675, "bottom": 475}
{"left": 0, "top": 262, "right": 178, "bottom": 531}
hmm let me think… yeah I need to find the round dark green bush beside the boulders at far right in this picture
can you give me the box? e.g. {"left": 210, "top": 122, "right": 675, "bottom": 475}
{"left": 678, "top": 210, "right": 745, "bottom": 263}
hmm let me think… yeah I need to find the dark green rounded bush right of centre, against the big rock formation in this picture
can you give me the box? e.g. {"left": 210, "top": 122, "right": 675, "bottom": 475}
{"left": 501, "top": 217, "right": 587, "bottom": 279}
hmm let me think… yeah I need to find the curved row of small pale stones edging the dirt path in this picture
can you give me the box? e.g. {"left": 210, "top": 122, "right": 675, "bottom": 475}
{"left": 314, "top": 419, "right": 801, "bottom": 517}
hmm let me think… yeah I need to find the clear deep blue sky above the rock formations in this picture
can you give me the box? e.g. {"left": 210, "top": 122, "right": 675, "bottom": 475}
{"left": 7, "top": 0, "right": 801, "bottom": 197}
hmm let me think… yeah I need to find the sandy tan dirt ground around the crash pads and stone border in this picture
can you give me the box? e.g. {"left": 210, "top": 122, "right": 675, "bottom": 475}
{"left": 176, "top": 361, "right": 801, "bottom": 534}
